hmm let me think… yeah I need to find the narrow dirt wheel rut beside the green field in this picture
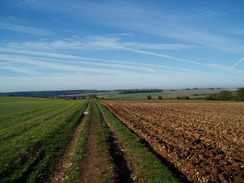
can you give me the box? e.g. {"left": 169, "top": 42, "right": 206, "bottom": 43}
{"left": 48, "top": 106, "right": 89, "bottom": 183}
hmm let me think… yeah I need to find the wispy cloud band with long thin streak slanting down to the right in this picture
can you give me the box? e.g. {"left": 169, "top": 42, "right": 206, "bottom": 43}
{"left": 3, "top": 36, "right": 228, "bottom": 70}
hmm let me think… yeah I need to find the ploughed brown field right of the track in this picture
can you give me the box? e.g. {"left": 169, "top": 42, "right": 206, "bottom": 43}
{"left": 102, "top": 100, "right": 244, "bottom": 182}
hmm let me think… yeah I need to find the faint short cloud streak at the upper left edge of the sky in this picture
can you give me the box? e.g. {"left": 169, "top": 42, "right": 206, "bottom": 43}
{"left": 0, "top": 22, "right": 53, "bottom": 36}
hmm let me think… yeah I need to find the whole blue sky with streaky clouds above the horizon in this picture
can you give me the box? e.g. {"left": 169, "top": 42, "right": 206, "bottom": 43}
{"left": 0, "top": 0, "right": 244, "bottom": 92}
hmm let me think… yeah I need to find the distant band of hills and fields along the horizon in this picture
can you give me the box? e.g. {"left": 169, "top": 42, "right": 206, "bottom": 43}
{"left": 0, "top": 88, "right": 237, "bottom": 99}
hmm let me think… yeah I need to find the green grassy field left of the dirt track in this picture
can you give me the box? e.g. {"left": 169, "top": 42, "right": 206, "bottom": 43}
{"left": 0, "top": 97, "right": 87, "bottom": 182}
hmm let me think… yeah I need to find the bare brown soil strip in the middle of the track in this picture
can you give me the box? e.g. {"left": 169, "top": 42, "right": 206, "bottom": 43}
{"left": 74, "top": 105, "right": 113, "bottom": 183}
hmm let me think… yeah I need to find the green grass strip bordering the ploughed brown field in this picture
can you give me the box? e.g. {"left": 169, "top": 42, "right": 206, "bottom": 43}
{"left": 98, "top": 103, "right": 179, "bottom": 183}
